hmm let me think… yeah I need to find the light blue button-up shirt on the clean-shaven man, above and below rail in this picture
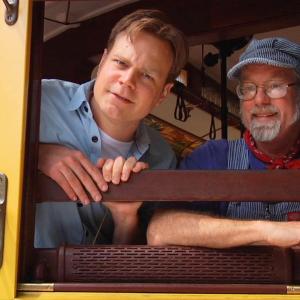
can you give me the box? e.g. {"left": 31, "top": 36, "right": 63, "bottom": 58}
{"left": 35, "top": 79, "right": 176, "bottom": 248}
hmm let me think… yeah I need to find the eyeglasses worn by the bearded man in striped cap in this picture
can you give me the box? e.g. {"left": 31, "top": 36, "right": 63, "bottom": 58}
{"left": 236, "top": 82, "right": 299, "bottom": 101}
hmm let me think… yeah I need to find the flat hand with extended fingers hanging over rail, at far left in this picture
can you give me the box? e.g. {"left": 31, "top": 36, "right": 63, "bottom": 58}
{"left": 38, "top": 144, "right": 108, "bottom": 204}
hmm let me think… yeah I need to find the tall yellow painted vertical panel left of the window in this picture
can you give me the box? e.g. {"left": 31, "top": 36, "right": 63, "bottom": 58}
{"left": 0, "top": 0, "right": 32, "bottom": 300}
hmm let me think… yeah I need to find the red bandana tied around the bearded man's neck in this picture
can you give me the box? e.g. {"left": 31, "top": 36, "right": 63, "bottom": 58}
{"left": 244, "top": 130, "right": 300, "bottom": 169}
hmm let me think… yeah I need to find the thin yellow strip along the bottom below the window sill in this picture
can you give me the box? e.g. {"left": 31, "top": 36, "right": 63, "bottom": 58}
{"left": 16, "top": 292, "right": 300, "bottom": 300}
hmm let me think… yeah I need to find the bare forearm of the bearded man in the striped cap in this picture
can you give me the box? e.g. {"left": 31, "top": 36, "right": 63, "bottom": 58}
{"left": 147, "top": 211, "right": 300, "bottom": 248}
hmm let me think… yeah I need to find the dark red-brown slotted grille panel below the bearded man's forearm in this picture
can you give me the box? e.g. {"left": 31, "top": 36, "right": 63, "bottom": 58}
{"left": 58, "top": 246, "right": 291, "bottom": 283}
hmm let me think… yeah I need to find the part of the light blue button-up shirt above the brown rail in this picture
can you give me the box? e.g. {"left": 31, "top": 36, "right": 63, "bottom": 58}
{"left": 40, "top": 79, "right": 176, "bottom": 169}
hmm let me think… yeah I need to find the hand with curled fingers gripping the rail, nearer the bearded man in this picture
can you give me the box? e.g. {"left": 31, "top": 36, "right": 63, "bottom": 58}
{"left": 97, "top": 156, "right": 149, "bottom": 184}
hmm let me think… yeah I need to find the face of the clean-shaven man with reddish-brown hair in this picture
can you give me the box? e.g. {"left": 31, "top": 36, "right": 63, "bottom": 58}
{"left": 93, "top": 31, "right": 173, "bottom": 134}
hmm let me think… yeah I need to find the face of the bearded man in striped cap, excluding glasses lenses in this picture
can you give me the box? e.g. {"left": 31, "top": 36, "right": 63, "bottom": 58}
{"left": 240, "top": 64, "right": 300, "bottom": 142}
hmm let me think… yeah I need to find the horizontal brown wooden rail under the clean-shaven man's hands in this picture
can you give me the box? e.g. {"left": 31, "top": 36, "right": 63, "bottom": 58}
{"left": 37, "top": 170, "right": 300, "bottom": 202}
